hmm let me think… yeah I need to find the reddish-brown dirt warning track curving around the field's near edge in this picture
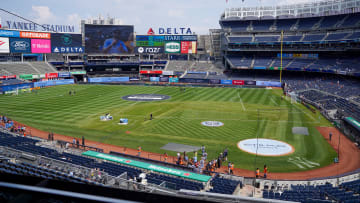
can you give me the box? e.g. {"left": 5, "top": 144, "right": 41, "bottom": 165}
{"left": 7, "top": 118, "right": 360, "bottom": 180}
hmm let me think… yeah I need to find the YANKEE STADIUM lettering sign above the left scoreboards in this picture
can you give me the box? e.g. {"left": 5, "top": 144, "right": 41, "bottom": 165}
{"left": 4, "top": 21, "right": 75, "bottom": 32}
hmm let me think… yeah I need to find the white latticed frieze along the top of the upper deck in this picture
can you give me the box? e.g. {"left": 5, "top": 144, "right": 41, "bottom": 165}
{"left": 221, "top": 0, "right": 360, "bottom": 20}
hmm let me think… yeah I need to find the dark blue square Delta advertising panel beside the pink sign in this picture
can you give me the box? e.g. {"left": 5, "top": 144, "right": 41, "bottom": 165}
{"left": 51, "top": 33, "right": 85, "bottom": 53}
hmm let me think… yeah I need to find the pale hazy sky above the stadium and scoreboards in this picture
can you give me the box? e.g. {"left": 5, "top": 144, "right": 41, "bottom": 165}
{"left": 0, "top": 0, "right": 315, "bottom": 34}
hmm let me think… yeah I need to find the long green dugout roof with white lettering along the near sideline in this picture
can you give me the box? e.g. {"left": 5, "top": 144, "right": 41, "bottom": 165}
{"left": 82, "top": 151, "right": 211, "bottom": 182}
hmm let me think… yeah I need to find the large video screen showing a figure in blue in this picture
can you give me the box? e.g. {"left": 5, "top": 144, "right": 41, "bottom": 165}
{"left": 85, "top": 24, "right": 135, "bottom": 54}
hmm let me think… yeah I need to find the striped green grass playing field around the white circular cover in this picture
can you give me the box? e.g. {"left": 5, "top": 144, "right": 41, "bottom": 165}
{"left": 0, "top": 85, "right": 336, "bottom": 172}
